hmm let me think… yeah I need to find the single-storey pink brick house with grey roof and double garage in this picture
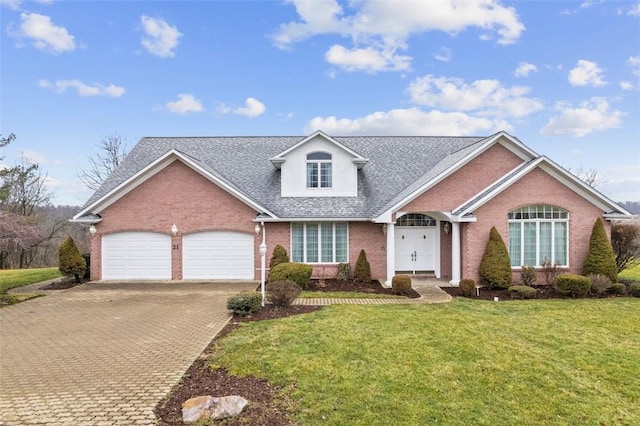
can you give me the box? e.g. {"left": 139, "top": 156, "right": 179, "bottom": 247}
{"left": 72, "top": 131, "right": 631, "bottom": 285}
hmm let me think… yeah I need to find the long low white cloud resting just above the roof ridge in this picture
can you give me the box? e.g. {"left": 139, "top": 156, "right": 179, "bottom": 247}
{"left": 305, "top": 108, "right": 504, "bottom": 136}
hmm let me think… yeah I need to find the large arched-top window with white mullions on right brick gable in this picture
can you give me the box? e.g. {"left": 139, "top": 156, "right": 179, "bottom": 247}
{"left": 508, "top": 205, "right": 569, "bottom": 267}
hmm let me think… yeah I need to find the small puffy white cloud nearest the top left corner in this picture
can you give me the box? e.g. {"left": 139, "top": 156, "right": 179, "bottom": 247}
{"left": 9, "top": 13, "right": 76, "bottom": 54}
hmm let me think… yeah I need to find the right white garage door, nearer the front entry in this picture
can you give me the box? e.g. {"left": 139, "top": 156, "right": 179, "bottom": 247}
{"left": 182, "top": 231, "right": 254, "bottom": 280}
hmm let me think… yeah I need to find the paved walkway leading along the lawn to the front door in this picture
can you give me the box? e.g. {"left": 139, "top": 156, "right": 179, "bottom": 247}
{"left": 293, "top": 278, "right": 451, "bottom": 306}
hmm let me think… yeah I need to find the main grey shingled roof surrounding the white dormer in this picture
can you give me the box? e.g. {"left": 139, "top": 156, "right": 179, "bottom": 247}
{"left": 82, "top": 136, "right": 486, "bottom": 219}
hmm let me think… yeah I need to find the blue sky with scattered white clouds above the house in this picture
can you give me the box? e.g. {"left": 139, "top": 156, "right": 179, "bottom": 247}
{"left": 0, "top": 0, "right": 640, "bottom": 205}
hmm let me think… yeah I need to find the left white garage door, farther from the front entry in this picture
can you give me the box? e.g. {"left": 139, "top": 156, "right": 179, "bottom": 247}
{"left": 102, "top": 232, "right": 171, "bottom": 280}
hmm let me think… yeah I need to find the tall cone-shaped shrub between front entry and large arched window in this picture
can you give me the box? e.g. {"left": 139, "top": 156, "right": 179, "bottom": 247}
{"left": 479, "top": 226, "right": 512, "bottom": 289}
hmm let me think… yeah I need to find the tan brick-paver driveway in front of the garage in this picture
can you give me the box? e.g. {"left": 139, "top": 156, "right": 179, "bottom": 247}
{"left": 0, "top": 282, "right": 256, "bottom": 425}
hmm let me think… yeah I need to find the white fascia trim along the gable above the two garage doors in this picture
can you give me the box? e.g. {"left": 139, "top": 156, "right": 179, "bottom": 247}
{"left": 73, "top": 149, "right": 275, "bottom": 220}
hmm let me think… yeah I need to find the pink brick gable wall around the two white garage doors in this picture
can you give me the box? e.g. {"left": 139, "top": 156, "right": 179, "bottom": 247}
{"left": 91, "top": 161, "right": 260, "bottom": 280}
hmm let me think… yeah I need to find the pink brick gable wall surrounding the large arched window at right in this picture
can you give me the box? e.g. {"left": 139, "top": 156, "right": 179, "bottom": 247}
{"left": 461, "top": 169, "right": 610, "bottom": 283}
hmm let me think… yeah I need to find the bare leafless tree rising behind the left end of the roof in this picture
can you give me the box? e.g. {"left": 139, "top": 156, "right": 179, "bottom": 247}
{"left": 78, "top": 134, "right": 129, "bottom": 191}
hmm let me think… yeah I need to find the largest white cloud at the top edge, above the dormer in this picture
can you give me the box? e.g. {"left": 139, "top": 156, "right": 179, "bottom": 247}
{"left": 273, "top": 0, "right": 525, "bottom": 71}
